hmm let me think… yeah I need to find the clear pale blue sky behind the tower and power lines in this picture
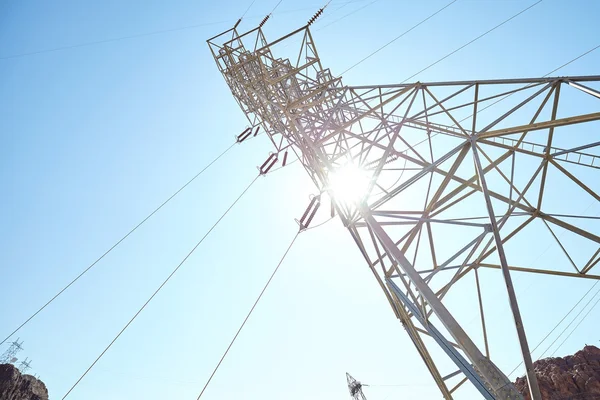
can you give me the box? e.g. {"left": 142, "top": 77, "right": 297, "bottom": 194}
{"left": 0, "top": 0, "right": 600, "bottom": 400}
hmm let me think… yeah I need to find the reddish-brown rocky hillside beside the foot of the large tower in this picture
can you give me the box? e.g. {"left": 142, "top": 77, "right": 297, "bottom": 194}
{"left": 515, "top": 346, "right": 600, "bottom": 400}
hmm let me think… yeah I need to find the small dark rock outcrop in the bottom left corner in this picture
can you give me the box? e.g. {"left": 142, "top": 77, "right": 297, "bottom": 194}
{"left": 0, "top": 364, "right": 48, "bottom": 400}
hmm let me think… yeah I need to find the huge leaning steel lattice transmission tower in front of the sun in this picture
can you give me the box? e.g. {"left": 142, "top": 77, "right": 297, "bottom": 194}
{"left": 208, "top": 22, "right": 600, "bottom": 399}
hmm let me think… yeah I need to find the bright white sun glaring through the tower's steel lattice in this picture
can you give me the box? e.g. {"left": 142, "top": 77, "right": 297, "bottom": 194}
{"left": 328, "top": 162, "right": 371, "bottom": 206}
